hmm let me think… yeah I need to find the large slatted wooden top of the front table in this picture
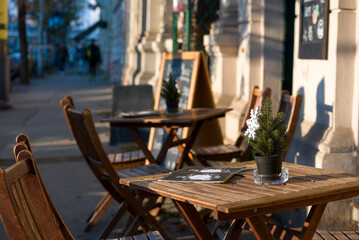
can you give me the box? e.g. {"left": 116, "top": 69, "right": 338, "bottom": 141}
{"left": 120, "top": 161, "right": 359, "bottom": 219}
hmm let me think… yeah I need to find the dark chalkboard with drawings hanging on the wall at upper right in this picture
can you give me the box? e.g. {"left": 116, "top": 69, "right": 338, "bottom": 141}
{"left": 299, "top": 0, "right": 328, "bottom": 59}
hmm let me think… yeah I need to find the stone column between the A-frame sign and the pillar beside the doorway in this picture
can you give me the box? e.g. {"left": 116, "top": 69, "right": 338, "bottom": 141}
{"left": 203, "top": 0, "right": 241, "bottom": 141}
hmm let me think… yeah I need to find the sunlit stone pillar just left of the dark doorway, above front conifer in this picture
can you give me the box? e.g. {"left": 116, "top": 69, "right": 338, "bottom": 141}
{"left": 237, "top": 0, "right": 284, "bottom": 106}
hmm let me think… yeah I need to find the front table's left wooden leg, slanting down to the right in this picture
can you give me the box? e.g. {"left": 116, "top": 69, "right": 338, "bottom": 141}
{"left": 172, "top": 199, "right": 214, "bottom": 240}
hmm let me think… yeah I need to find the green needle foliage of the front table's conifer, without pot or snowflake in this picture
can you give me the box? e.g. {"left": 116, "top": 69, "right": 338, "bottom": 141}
{"left": 248, "top": 97, "right": 290, "bottom": 157}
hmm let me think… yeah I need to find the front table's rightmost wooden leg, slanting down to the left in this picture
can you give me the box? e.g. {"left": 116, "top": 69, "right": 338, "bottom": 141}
{"left": 299, "top": 203, "right": 327, "bottom": 240}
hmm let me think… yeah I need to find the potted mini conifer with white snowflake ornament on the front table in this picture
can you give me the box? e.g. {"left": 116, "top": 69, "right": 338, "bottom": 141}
{"left": 245, "top": 97, "right": 290, "bottom": 180}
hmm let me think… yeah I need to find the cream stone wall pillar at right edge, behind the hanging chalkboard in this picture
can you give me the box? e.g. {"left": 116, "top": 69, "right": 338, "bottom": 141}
{"left": 291, "top": 0, "right": 358, "bottom": 227}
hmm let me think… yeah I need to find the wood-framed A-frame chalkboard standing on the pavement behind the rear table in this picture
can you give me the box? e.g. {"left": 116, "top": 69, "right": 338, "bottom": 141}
{"left": 148, "top": 52, "right": 222, "bottom": 169}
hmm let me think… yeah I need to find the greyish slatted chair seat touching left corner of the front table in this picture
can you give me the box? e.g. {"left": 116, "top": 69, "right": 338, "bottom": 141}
{"left": 117, "top": 164, "right": 170, "bottom": 178}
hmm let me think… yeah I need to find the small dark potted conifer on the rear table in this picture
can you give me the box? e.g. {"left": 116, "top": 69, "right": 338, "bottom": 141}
{"left": 161, "top": 73, "right": 181, "bottom": 113}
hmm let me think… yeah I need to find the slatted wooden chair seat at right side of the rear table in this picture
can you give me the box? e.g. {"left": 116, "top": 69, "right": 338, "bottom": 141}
{"left": 191, "top": 144, "right": 242, "bottom": 161}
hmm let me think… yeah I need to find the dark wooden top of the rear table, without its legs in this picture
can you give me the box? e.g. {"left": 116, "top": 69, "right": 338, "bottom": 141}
{"left": 101, "top": 108, "right": 232, "bottom": 127}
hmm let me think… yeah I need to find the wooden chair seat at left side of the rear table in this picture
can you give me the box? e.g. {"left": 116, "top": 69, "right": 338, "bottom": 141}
{"left": 107, "top": 150, "right": 146, "bottom": 169}
